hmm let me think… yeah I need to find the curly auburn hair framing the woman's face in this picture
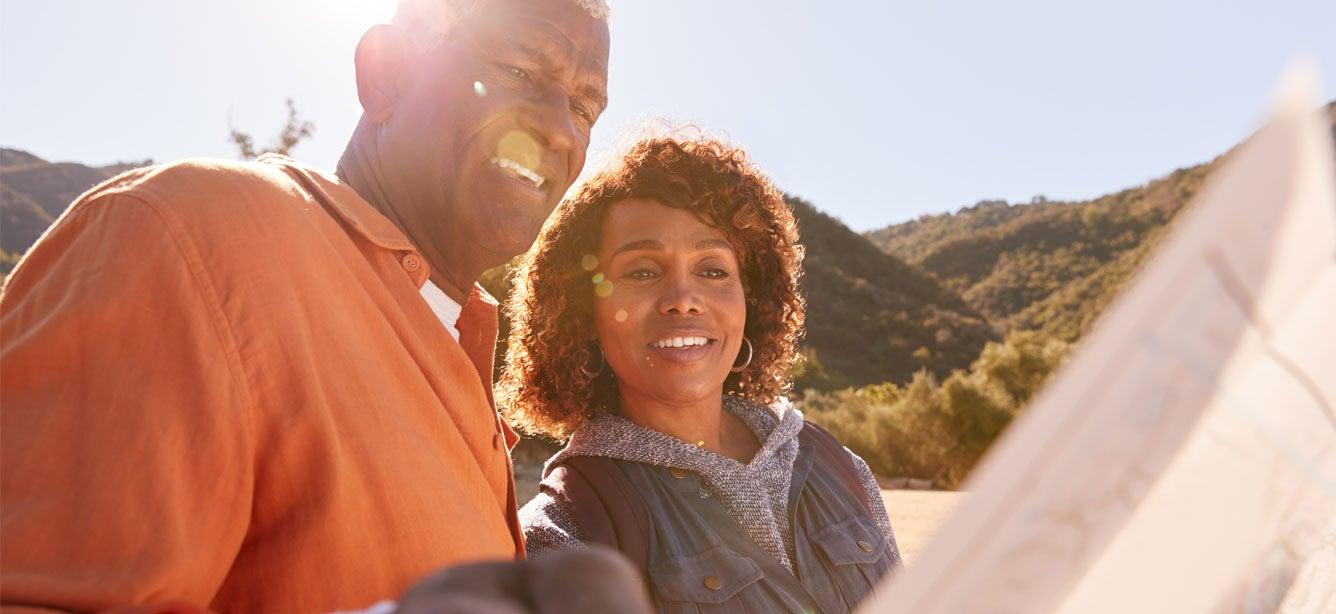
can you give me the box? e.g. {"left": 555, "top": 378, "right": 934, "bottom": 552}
{"left": 497, "top": 136, "right": 804, "bottom": 440}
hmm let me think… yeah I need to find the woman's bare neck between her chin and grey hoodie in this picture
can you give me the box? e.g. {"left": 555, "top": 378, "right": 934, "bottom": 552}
{"left": 620, "top": 391, "right": 760, "bottom": 463}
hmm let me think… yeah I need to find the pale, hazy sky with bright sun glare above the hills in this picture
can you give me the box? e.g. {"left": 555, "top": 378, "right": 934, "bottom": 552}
{"left": 0, "top": 0, "right": 1336, "bottom": 231}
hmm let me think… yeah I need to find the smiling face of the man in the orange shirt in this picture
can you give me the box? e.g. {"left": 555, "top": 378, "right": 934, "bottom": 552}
{"left": 379, "top": 0, "right": 608, "bottom": 264}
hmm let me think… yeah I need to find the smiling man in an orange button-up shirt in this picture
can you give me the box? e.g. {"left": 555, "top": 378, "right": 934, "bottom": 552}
{"left": 0, "top": 0, "right": 646, "bottom": 611}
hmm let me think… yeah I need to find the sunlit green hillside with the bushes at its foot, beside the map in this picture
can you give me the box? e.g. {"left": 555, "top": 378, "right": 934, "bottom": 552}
{"left": 800, "top": 103, "right": 1336, "bottom": 489}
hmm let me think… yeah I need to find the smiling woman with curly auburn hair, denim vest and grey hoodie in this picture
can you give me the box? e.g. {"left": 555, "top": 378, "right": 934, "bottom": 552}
{"left": 497, "top": 132, "right": 899, "bottom": 611}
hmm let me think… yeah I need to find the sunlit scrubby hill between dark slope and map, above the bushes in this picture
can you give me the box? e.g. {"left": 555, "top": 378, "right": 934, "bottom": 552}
{"left": 866, "top": 103, "right": 1336, "bottom": 342}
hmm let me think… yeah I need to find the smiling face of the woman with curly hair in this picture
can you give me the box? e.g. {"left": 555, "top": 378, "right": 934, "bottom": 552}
{"left": 593, "top": 199, "right": 747, "bottom": 404}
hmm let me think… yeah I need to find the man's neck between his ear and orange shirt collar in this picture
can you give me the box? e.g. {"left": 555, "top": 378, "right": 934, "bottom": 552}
{"left": 335, "top": 127, "right": 489, "bottom": 304}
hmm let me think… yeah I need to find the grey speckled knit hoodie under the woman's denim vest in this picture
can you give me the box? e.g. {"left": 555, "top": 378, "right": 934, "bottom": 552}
{"left": 520, "top": 395, "right": 895, "bottom": 571}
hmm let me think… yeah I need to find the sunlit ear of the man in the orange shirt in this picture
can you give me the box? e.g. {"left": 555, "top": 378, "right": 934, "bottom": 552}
{"left": 353, "top": 24, "right": 413, "bottom": 124}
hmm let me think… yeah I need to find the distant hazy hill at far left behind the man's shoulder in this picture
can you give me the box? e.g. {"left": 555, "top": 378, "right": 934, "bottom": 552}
{"left": 0, "top": 148, "right": 152, "bottom": 272}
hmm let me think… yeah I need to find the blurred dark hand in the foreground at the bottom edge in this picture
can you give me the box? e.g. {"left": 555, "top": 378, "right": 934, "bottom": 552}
{"left": 397, "top": 546, "right": 653, "bottom": 614}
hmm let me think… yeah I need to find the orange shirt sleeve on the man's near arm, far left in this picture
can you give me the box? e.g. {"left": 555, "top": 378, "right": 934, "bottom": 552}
{"left": 0, "top": 192, "right": 255, "bottom": 610}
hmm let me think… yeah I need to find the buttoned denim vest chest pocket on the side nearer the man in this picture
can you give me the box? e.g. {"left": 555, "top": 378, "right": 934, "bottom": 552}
{"left": 649, "top": 546, "right": 762, "bottom": 607}
